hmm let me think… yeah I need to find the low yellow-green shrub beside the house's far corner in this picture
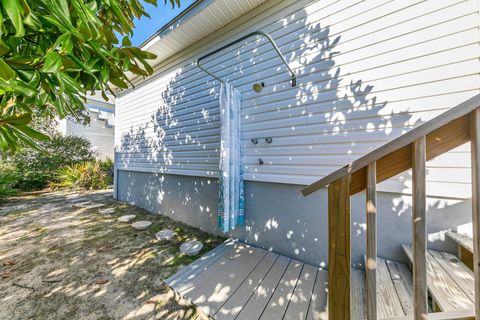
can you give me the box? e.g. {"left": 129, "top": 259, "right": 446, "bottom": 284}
{"left": 50, "top": 160, "right": 113, "bottom": 189}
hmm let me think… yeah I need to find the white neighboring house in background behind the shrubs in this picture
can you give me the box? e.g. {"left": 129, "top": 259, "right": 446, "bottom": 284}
{"left": 58, "top": 95, "right": 115, "bottom": 159}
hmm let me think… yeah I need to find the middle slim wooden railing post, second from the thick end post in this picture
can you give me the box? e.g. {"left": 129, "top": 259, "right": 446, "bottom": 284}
{"left": 412, "top": 136, "right": 428, "bottom": 320}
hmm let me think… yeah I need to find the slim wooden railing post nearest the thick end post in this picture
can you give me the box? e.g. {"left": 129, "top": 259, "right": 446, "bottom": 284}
{"left": 365, "top": 162, "right": 377, "bottom": 320}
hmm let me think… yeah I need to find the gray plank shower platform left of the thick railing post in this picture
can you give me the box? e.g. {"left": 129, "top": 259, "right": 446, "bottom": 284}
{"left": 166, "top": 241, "right": 327, "bottom": 319}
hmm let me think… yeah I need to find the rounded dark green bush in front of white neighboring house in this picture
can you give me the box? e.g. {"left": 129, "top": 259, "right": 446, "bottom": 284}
{"left": 8, "top": 133, "right": 94, "bottom": 190}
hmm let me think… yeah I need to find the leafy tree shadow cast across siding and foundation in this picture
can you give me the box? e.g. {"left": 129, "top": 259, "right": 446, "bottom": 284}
{"left": 116, "top": 6, "right": 468, "bottom": 265}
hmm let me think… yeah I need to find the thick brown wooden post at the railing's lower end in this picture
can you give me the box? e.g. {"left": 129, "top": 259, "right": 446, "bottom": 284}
{"left": 328, "top": 174, "right": 351, "bottom": 320}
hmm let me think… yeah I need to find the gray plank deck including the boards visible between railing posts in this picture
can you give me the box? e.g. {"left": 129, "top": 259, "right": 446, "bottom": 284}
{"left": 166, "top": 241, "right": 422, "bottom": 320}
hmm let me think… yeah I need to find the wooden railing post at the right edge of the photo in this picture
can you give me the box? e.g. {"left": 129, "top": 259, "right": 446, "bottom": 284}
{"left": 470, "top": 109, "right": 480, "bottom": 319}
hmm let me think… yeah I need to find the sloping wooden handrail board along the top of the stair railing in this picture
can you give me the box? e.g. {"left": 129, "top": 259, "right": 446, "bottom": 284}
{"left": 302, "top": 94, "right": 480, "bottom": 196}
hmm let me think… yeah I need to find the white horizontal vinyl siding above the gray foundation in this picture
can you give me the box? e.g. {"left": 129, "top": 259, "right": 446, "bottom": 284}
{"left": 116, "top": 0, "right": 480, "bottom": 198}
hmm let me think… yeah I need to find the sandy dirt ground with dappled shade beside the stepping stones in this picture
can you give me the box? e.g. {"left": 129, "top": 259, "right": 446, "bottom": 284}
{"left": 0, "top": 190, "right": 224, "bottom": 320}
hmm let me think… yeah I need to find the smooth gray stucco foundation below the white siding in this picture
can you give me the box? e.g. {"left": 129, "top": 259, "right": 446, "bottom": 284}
{"left": 116, "top": 171, "right": 471, "bottom": 266}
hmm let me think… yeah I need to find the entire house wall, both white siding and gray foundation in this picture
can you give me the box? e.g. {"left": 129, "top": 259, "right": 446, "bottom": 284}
{"left": 115, "top": 0, "right": 480, "bottom": 263}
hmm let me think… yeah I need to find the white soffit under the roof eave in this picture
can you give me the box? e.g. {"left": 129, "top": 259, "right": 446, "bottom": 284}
{"left": 137, "top": 0, "right": 268, "bottom": 73}
